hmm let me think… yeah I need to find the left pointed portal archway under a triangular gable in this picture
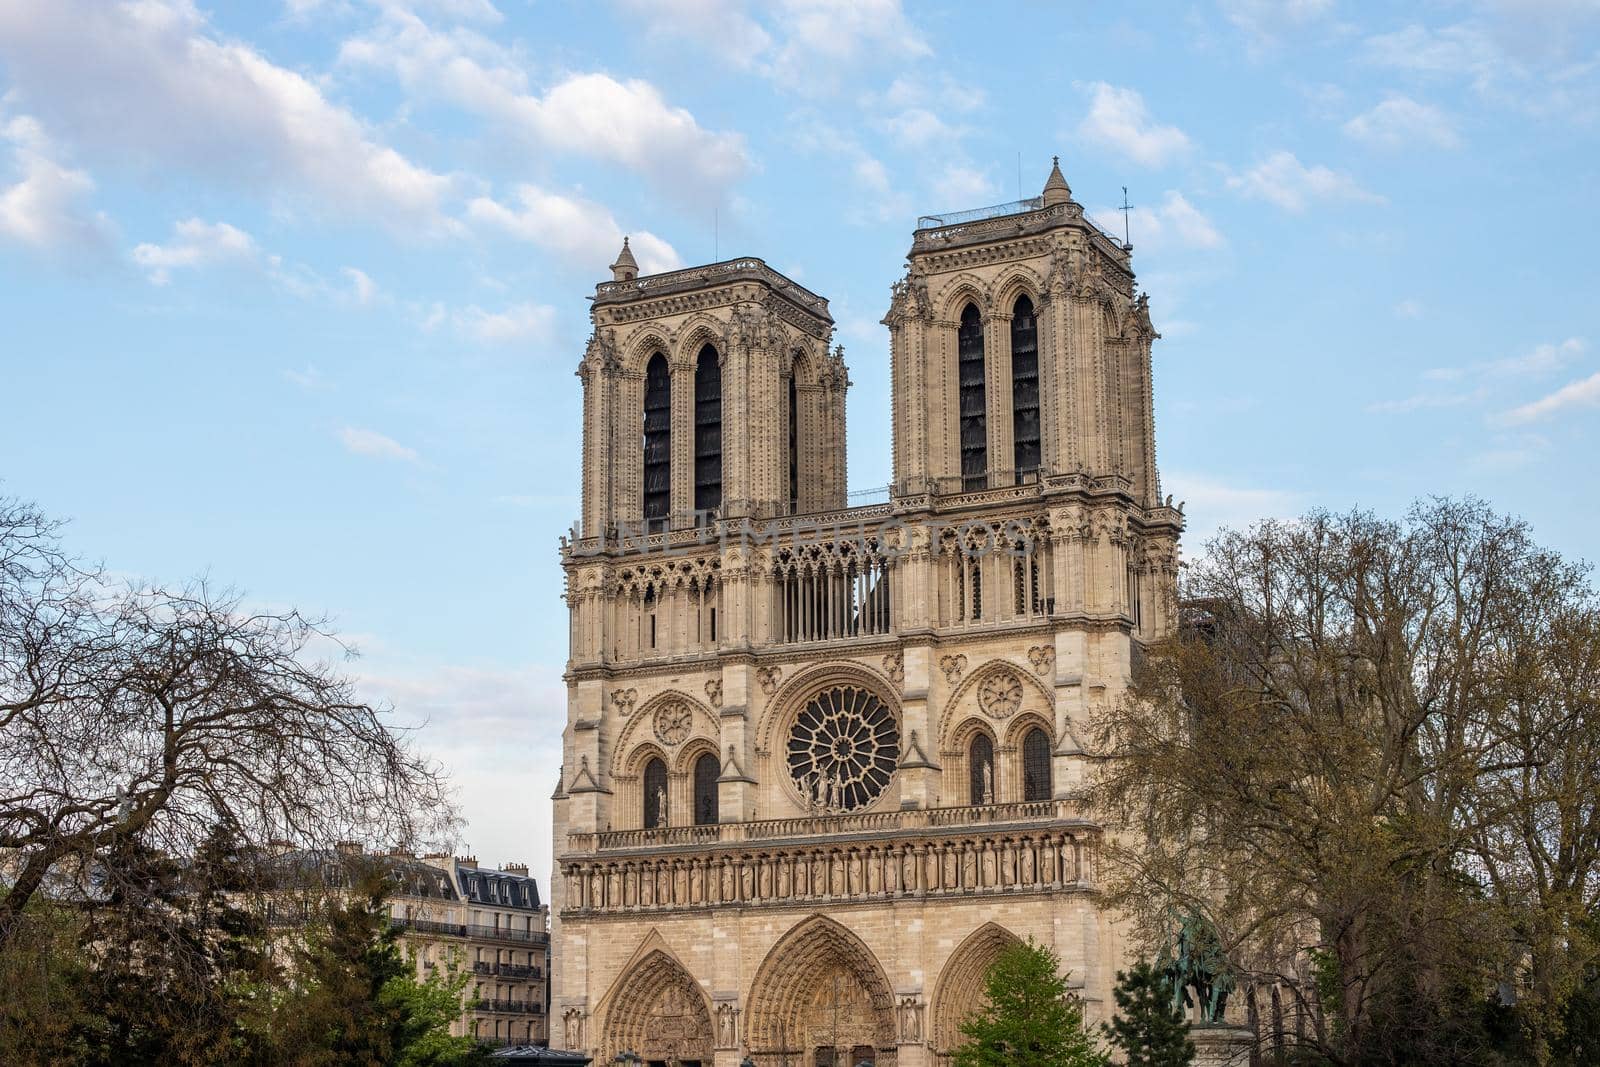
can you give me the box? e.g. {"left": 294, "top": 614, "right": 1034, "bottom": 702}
{"left": 600, "top": 950, "right": 712, "bottom": 1067}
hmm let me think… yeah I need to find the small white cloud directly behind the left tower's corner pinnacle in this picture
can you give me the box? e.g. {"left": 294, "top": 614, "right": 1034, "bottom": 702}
{"left": 467, "top": 184, "right": 683, "bottom": 277}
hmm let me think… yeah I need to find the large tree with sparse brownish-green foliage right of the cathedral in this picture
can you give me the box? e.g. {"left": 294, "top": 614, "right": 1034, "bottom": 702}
{"left": 1093, "top": 501, "right": 1600, "bottom": 1062}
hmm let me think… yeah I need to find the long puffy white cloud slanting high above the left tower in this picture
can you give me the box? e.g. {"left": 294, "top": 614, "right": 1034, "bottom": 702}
{"left": 339, "top": 11, "right": 750, "bottom": 194}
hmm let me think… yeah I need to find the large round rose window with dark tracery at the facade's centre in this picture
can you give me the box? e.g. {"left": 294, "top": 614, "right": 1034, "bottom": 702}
{"left": 789, "top": 685, "right": 899, "bottom": 811}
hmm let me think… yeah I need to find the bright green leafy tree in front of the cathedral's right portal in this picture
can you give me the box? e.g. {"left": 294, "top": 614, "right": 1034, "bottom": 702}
{"left": 955, "top": 939, "right": 1106, "bottom": 1067}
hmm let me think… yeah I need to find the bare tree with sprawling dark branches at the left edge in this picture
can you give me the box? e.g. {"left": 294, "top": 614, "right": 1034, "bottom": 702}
{"left": 0, "top": 498, "right": 453, "bottom": 947}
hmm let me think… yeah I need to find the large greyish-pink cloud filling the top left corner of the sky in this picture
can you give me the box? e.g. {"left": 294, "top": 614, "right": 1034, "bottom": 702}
{"left": 0, "top": 0, "right": 451, "bottom": 226}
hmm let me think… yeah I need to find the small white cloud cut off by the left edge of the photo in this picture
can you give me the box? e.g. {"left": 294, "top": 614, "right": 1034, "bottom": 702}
{"left": 0, "top": 115, "right": 114, "bottom": 251}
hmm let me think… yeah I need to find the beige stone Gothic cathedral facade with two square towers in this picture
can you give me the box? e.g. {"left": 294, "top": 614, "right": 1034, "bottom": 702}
{"left": 550, "top": 160, "right": 1181, "bottom": 1067}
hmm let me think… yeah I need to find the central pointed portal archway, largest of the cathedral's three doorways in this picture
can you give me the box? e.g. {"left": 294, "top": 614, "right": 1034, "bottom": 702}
{"left": 746, "top": 915, "right": 896, "bottom": 1067}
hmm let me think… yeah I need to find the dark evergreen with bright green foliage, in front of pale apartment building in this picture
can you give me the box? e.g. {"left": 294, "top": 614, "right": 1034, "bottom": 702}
{"left": 274, "top": 870, "right": 488, "bottom": 1067}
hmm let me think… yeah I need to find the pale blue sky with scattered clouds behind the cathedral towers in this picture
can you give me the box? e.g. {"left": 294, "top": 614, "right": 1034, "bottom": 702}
{"left": 0, "top": 0, "right": 1600, "bottom": 878}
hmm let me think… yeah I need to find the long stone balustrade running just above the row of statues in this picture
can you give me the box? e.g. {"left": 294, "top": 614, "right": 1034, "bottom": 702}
{"left": 566, "top": 800, "right": 1093, "bottom": 851}
